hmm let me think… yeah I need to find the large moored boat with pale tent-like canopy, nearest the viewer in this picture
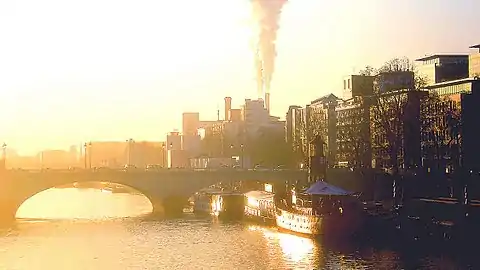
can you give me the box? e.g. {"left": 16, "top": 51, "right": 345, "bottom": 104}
{"left": 276, "top": 181, "right": 363, "bottom": 236}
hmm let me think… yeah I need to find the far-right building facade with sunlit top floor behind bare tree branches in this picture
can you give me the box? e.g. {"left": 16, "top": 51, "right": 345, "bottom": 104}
{"left": 421, "top": 78, "right": 480, "bottom": 172}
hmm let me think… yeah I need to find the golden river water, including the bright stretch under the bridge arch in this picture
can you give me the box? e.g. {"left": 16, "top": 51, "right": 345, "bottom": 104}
{"left": 0, "top": 188, "right": 478, "bottom": 270}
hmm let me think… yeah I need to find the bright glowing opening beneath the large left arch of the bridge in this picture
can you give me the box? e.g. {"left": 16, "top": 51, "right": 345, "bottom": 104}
{"left": 17, "top": 188, "right": 152, "bottom": 220}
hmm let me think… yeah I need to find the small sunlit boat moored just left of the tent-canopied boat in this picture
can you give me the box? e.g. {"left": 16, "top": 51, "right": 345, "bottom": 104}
{"left": 244, "top": 190, "right": 275, "bottom": 223}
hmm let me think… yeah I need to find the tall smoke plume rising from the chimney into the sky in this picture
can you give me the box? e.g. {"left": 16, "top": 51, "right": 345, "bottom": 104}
{"left": 251, "top": 0, "right": 287, "bottom": 95}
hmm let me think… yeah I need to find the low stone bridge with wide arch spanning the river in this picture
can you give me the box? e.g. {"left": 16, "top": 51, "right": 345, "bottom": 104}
{"left": 0, "top": 169, "right": 308, "bottom": 220}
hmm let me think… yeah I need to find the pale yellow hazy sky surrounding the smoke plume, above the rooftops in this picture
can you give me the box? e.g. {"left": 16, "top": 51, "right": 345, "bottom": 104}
{"left": 0, "top": 0, "right": 480, "bottom": 153}
